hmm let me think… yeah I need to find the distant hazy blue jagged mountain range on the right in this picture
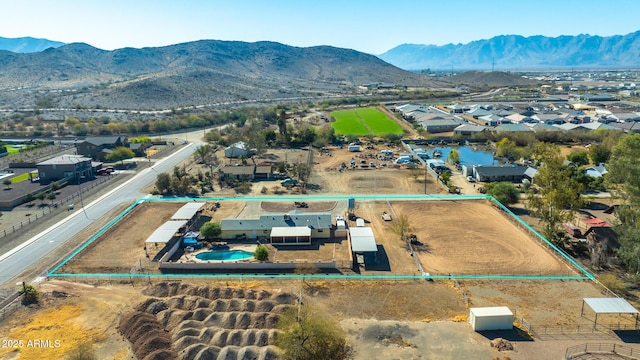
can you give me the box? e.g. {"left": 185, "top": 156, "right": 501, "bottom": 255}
{"left": 379, "top": 31, "right": 640, "bottom": 71}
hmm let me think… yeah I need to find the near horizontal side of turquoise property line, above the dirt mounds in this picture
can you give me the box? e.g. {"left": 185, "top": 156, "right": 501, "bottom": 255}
{"left": 51, "top": 274, "right": 591, "bottom": 280}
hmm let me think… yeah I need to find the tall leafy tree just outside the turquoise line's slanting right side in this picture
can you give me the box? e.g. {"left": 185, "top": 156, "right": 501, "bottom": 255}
{"left": 527, "top": 143, "right": 583, "bottom": 243}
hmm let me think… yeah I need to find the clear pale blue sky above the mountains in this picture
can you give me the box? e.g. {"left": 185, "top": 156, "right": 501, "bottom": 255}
{"left": 0, "top": 0, "right": 640, "bottom": 54}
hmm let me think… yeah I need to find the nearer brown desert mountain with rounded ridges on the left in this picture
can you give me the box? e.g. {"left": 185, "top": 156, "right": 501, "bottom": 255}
{"left": 0, "top": 40, "right": 432, "bottom": 109}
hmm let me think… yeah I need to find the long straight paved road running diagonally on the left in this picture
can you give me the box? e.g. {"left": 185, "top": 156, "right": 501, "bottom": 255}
{"left": 0, "top": 132, "right": 202, "bottom": 285}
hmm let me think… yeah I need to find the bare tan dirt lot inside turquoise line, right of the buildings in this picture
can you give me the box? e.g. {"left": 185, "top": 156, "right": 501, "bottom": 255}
{"left": 392, "top": 200, "right": 580, "bottom": 276}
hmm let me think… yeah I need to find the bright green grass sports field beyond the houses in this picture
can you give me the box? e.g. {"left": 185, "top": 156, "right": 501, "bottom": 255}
{"left": 330, "top": 108, "right": 402, "bottom": 136}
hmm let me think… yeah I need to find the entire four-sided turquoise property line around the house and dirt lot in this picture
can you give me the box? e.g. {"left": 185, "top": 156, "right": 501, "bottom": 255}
{"left": 48, "top": 195, "right": 595, "bottom": 280}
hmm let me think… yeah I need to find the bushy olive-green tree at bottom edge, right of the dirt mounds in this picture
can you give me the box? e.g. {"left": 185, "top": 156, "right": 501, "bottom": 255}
{"left": 277, "top": 304, "right": 348, "bottom": 360}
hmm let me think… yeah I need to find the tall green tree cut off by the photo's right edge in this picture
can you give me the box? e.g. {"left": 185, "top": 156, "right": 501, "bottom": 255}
{"left": 605, "top": 134, "right": 640, "bottom": 272}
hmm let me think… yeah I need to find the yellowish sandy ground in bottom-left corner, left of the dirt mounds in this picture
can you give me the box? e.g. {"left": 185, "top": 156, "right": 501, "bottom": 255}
{"left": 0, "top": 280, "right": 141, "bottom": 360}
